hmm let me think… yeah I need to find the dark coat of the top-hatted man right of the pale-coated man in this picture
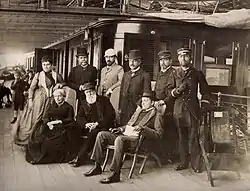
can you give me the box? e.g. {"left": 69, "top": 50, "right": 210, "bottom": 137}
{"left": 119, "top": 69, "right": 151, "bottom": 125}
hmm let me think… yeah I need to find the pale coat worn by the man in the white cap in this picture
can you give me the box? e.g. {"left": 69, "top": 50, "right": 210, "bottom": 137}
{"left": 98, "top": 64, "right": 124, "bottom": 95}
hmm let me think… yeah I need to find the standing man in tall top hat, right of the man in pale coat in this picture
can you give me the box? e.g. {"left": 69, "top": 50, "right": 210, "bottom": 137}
{"left": 119, "top": 50, "right": 151, "bottom": 125}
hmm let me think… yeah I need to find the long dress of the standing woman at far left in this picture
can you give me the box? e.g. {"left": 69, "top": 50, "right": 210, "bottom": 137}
{"left": 13, "top": 71, "right": 63, "bottom": 145}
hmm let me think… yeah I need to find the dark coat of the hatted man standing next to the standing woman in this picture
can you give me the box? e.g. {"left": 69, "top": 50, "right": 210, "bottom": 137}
{"left": 68, "top": 65, "right": 97, "bottom": 98}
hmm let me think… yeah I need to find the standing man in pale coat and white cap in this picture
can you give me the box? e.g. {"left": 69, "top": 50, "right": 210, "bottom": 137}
{"left": 98, "top": 48, "right": 124, "bottom": 97}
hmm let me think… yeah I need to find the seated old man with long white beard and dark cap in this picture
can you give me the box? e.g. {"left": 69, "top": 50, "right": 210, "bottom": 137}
{"left": 69, "top": 83, "right": 115, "bottom": 167}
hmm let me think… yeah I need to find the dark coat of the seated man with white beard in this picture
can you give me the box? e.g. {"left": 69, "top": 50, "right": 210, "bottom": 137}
{"left": 76, "top": 96, "right": 115, "bottom": 130}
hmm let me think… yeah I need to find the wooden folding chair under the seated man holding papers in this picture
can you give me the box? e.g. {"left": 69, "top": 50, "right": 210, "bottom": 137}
{"left": 102, "top": 135, "right": 162, "bottom": 178}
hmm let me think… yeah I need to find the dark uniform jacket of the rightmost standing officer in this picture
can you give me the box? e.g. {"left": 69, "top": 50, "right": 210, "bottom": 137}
{"left": 166, "top": 67, "right": 210, "bottom": 120}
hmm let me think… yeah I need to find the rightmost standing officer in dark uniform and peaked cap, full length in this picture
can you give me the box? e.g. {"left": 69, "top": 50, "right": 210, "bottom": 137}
{"left": 168, "top": 48, "right": 210, "bottom": 173}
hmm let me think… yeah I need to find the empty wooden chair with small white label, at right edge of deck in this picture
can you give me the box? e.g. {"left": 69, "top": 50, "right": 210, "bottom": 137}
{"left": 199, "top": 106, "right": 247, "bottom": 187}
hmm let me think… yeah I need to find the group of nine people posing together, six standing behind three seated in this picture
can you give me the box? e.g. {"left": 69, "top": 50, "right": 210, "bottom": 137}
{"left": 11, "top": 45, "right": 210, "bottom": 184}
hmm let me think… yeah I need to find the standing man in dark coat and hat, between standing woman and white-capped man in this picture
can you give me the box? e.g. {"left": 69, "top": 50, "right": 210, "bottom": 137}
{"left": 68, "top": 47, "right": 97, "bottom": 106}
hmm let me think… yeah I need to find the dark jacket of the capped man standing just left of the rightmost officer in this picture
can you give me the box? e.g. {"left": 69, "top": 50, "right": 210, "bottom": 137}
{"left": 155, "top": 67, "right": 175, "bottom": 113}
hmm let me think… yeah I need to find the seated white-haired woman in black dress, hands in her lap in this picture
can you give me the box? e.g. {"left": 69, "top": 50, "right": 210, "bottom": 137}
{"left": 26, "top": 89, "right": 80, "bottom": 164}
